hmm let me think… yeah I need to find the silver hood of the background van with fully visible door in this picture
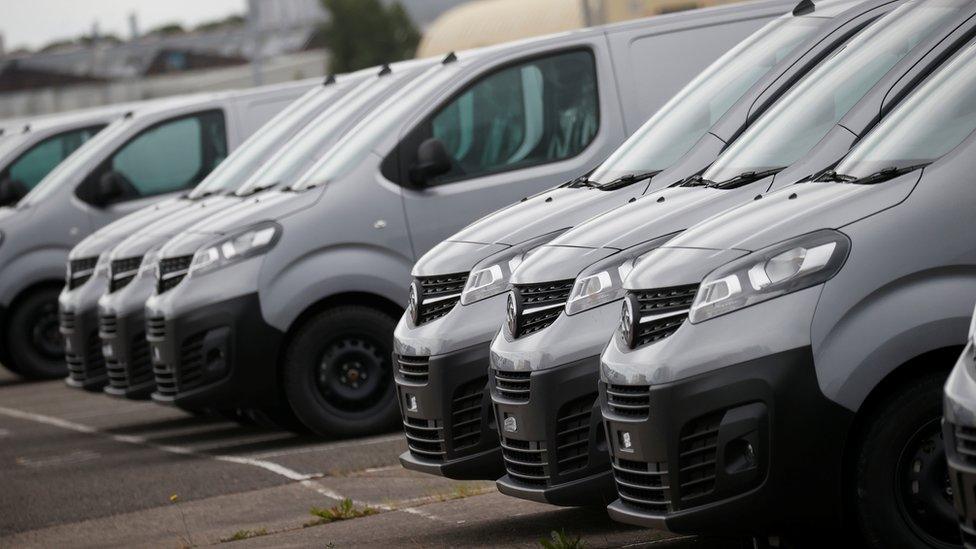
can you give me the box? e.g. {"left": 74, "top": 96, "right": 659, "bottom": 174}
{"left": 160, "top": 188, "right": 324, "bottom": 258}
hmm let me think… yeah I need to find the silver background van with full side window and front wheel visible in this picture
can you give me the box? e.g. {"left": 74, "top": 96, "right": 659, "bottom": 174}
{"left": 146, "top": 2, "right": 784, "bottom": 434}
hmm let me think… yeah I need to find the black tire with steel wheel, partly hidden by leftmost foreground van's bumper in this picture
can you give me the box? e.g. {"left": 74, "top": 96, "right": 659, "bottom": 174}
{"left": 283, "top": 305, "right": 400, "bottom": 436}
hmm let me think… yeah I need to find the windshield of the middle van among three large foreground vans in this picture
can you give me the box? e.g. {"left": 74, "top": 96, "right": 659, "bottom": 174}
{"left": 702, "top": 0, "right": 964, "bottom": 184}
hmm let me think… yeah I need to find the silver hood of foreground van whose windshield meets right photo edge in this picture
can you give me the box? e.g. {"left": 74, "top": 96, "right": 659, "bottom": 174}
{"left": 668, "top": 170, "right": 923, "bottom": 252}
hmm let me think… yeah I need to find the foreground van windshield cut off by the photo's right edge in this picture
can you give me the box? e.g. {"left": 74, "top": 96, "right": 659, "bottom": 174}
{"left": 834, "top": 44, "right": 976, "bottom": 183}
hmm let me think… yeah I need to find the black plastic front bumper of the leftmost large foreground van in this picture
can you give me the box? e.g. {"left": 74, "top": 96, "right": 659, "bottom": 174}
{"left": 393, "top": 343, "right": 504, "bottom": 480}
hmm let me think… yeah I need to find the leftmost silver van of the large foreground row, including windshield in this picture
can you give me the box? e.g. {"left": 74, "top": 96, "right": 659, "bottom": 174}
{"left": 394, "top": 2, "right": 897, "bottom": 480}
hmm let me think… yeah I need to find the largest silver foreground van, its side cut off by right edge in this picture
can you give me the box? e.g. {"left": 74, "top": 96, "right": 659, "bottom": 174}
{"left": 599, "top": 31, "right": 976, "bottom": 548}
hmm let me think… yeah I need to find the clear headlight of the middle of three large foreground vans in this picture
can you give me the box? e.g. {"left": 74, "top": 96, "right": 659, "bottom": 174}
{"left": 566, "top": 233, "right": 678, "bottom": 315}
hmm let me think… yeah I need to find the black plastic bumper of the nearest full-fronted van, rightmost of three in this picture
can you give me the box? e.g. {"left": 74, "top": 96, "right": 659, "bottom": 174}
{"left": 600, "top": 347, "right": 853, "bottom": 535}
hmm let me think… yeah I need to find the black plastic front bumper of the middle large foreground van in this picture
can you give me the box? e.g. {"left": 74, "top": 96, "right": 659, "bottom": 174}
{"left": 492, "top": 356, "right": 616, "bottom": 506}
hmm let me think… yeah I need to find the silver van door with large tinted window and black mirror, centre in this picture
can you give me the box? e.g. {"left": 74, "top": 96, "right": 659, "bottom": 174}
{"left": 399, "top": 46, "right": 623, "bottom": 256}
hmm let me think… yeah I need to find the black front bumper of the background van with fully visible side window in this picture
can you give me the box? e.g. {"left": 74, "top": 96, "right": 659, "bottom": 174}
{"left": 146, "top": 293, "right": 282, "bottom": 409}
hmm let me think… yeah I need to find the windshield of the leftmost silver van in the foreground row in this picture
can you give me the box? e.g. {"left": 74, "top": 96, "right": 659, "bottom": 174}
{"left": 590, "top": 17, "right": 830, "bottom": 185}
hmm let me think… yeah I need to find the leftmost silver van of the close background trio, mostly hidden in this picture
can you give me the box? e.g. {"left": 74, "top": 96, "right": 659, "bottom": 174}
{"left": 58, "top": 69, "right": 376, "bottom": 390}
